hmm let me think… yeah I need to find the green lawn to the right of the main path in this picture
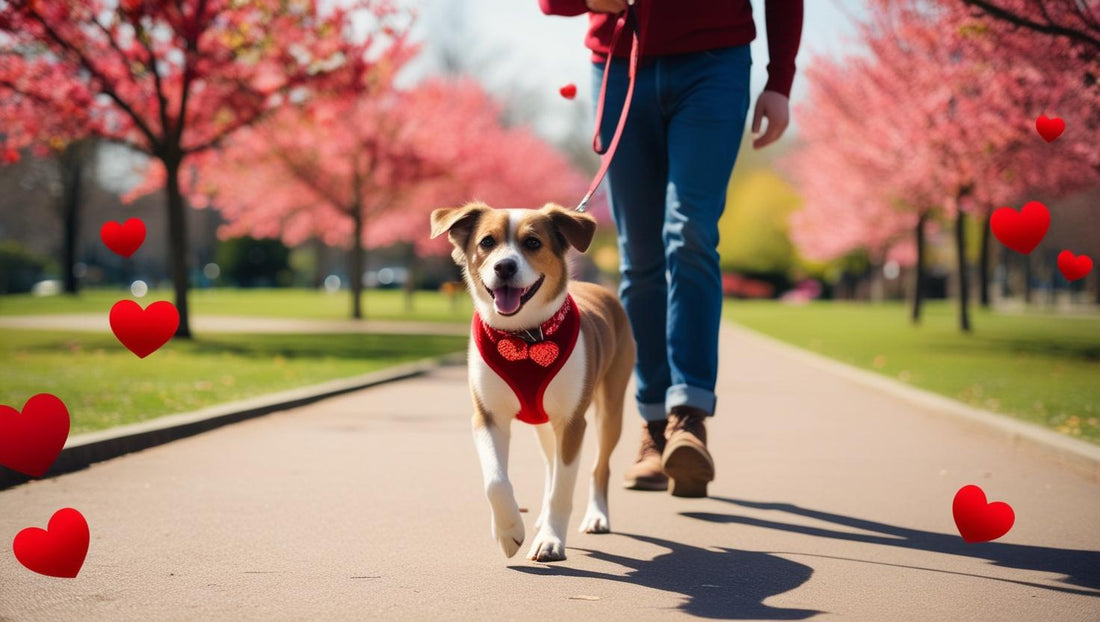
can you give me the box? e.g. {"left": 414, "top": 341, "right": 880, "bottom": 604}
{"left": 724, "top": 301, "right": 1100, "bottom": 444}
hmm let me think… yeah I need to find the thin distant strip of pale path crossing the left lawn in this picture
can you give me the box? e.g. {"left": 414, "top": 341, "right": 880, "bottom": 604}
{"left": 0, "top": 313, "right": 470, "bottom": 335}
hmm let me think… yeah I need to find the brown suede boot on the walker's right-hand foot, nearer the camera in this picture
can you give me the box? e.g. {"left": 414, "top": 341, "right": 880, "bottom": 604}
{"left": 661, "top": 407, "right": 714, "bottom": 496}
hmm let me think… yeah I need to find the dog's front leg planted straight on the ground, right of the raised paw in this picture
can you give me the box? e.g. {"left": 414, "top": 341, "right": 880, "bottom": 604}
{"left": 527, "top": 413, "right": 585, "bottom": 561}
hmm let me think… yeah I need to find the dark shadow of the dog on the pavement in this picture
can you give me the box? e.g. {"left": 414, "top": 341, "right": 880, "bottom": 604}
{"left": 509, "top": 534, "right": 822, "bottom": 620}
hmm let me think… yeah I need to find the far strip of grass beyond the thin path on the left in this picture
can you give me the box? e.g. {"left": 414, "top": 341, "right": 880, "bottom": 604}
{"left": 0, "top": 288, "right": 472, "bottom": 323}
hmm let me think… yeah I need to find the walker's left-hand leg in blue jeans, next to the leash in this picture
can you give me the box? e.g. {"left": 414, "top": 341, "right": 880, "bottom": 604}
{"left": 593, "top": 61, "right": 670, "bottom": 422}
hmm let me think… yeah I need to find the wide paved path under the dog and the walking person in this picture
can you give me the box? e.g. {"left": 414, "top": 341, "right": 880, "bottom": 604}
{"left": 0, "top": 327, "right": 1100, "bottom": 622}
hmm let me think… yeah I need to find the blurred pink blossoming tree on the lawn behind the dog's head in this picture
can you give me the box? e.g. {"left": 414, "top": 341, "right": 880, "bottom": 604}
{"left": 133, "top": 76, "right": 585, "bottom": 318}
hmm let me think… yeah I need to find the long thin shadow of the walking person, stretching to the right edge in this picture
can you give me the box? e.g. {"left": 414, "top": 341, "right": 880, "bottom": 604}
{"left": 681, "top": 496, "right": 1100, "bottom": 597}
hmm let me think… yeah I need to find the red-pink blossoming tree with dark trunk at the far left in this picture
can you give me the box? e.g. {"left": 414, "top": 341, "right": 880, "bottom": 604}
{"left": 0, "top": 0, "right": 409, "bottom": 337}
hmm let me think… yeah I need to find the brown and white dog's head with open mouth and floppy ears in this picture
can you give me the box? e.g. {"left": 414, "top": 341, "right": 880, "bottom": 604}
{"left": 431, "top": 203, "right": 596, "bottom": 330}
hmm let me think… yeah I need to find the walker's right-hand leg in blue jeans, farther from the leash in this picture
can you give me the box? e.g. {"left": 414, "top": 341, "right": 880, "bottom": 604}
{"left": 661, "top": 45, "right": 751, "bottom": 415}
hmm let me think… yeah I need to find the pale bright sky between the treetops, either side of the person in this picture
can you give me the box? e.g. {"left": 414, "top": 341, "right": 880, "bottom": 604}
{"left": 410, "top": 0, "right": 866, "bottom": 139}
